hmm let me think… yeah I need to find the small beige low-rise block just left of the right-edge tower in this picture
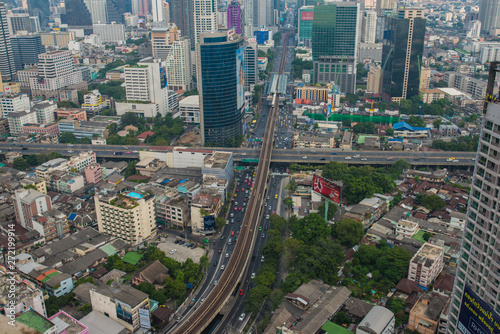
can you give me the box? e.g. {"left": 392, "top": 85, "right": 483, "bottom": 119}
{"left": 408, "top": 243, "right": 444, "bottom": 287}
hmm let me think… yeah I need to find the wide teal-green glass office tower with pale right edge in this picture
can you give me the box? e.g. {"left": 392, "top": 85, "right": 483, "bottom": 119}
{"left": 311, "top": 2, "right": 360, "bottom": 94}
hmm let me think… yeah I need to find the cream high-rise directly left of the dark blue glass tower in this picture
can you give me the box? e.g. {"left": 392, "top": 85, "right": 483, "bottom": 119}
{"left": 165, "top": 37, "right": 193, "bottom": 91}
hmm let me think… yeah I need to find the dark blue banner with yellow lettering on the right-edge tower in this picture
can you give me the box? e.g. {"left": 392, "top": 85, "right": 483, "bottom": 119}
{"left": 457, "top": 285, "right": 500, "bottom": 334}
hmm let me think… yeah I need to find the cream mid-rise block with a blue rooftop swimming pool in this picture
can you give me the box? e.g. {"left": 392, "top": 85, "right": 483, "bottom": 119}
{"left": 94, "top": 192, "right": 156, "bottom": 245}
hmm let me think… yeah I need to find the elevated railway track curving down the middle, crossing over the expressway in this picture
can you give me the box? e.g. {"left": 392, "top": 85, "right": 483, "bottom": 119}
{"left": 171, "top": 33, "right": 289, "bottom": 334}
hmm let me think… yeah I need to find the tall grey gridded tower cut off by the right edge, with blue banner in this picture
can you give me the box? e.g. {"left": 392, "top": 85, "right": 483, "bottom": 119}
{"left": 447, "top": 66, "right": 500, "bottom": 334}
